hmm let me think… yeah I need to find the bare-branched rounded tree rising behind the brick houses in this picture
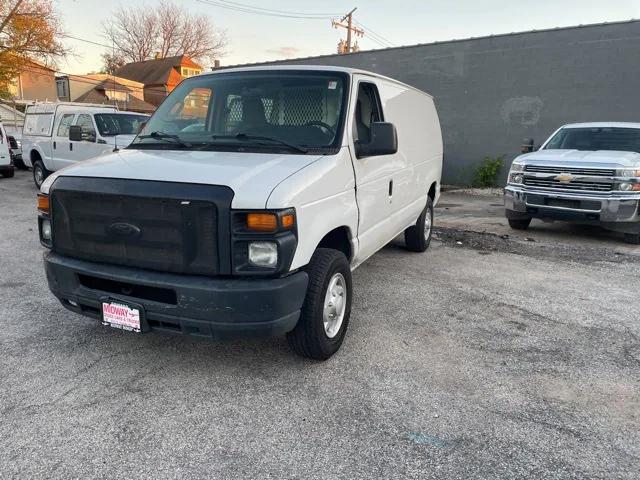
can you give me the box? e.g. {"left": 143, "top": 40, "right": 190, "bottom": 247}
{"left": 103, "top": 0, "right": 227, "bottom": 70}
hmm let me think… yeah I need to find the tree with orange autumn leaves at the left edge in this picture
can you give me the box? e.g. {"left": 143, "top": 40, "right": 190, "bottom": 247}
{"left": 0, "top": 0, "right": 68, "bottom": 96}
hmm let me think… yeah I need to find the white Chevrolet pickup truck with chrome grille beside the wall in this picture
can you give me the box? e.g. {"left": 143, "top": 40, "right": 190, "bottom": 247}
{"left": 505, "top": 122, "right": 640, "bottom": 244}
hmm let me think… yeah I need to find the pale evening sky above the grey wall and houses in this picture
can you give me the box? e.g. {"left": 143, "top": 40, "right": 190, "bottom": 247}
{"left": 54, "top": 0, "right": 640, "bottom": 74}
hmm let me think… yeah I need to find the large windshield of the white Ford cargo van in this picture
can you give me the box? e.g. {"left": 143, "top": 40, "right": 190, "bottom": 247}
{"left": 129, "top": 70, "right": 347, "bottom": 154}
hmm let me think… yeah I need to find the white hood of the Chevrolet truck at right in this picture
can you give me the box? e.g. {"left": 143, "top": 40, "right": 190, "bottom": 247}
{"left": 517, "top": 150, "right": 640, "bottom": 168}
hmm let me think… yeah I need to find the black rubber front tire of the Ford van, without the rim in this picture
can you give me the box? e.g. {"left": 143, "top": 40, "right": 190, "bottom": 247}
{"left": 287, "top": 248, "right": 352, "bottom": 360}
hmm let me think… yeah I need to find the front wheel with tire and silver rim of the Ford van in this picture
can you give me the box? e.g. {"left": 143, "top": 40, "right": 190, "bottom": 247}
{"left": 287, "top": 248, "right": 351, "bottom": 360}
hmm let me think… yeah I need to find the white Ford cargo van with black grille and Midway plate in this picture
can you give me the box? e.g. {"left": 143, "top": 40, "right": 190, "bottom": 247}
{"left": 38, "top": 66, "right": 442, "bottom": 359}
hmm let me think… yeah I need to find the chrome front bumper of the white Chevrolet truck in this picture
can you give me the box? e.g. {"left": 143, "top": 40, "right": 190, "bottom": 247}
{"left": 504, "top": 185, "right": 640, "bottom": 233}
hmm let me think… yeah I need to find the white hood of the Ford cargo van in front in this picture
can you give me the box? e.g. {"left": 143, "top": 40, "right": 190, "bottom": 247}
{"left": 41, "top": 150, "right": 321, "bottom": 208}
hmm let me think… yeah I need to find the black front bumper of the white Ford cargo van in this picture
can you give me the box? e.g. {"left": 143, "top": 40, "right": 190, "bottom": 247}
{"left": 44, "top": 252, "right": 308, "bottom": 339}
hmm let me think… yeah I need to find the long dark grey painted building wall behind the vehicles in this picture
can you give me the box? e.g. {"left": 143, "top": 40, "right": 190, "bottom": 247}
{"left": 228, "top": 21, "right": 640, "bottom": 183}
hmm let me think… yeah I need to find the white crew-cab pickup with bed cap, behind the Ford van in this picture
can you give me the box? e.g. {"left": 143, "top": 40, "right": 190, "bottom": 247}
{"left": 22, "top": 102, "right": 149, "bottom": 188}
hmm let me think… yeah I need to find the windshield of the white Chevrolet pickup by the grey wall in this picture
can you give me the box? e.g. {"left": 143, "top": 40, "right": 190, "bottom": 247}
{"left": 544, "top": 127, "right": 640, "bottom": 153}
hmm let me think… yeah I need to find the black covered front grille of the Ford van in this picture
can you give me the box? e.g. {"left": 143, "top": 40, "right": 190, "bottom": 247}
{"left": 51, "top": 190, "right": 219, "bottom": 275}
